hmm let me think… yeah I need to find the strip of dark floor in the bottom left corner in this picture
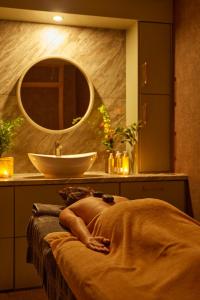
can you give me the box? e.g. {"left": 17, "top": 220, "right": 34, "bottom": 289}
{"left": 0, "top": 289, "right": 48, "bottom": 300}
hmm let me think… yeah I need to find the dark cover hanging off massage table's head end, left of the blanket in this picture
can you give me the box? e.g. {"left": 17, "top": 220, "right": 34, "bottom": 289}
{"left": 27, "top": 211, "right": 75, "bottom": 300}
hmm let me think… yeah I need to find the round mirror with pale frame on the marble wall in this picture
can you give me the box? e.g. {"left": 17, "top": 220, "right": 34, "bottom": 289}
{"left": 17, "top": 57, "right": 94, "bottom": 133}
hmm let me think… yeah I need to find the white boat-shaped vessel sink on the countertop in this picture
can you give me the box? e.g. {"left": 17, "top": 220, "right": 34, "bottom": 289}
{"left": 28, "top": 152, "right": 97, "bottom": 178}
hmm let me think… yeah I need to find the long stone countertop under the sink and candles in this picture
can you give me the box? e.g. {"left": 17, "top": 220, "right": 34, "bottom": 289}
{"left": 0, "top": 171, "right": 188, "bottom": 186}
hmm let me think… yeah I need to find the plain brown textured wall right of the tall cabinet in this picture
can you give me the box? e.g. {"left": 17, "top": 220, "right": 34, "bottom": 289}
{"left": 175, "top": 0, "right": 200, "bottom": 220}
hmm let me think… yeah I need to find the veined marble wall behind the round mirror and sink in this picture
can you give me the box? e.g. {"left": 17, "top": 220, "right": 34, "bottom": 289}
{"left": 0, "top": 21, "right": 126, "bottom": 173}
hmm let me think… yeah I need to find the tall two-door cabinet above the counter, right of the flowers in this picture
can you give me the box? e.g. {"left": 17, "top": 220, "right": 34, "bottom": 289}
{"left": 138, "top": 22, "right": 173, "bottom": 173}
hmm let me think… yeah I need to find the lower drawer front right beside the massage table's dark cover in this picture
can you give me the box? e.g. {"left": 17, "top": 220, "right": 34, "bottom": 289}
{"left": 14, "top": 238, "right": 41, "bottom": 289}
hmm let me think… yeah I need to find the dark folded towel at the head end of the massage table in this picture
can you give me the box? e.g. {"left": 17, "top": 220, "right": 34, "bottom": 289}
{"left": 32, "top": 203, "right": 64, "bottom": 217}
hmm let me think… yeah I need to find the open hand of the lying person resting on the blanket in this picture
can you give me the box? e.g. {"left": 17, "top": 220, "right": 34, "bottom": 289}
{"left": 86, "top": 236, "right": 110, "bottom": 254}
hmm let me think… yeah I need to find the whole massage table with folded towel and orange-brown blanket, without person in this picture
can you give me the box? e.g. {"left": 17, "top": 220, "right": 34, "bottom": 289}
{"left": 27, "top": 199, "right": 200, "bottom": 300}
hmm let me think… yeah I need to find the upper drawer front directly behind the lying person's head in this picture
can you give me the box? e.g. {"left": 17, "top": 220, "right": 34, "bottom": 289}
{"left": 15, "top": 183, "right": 119, "bottom": 237}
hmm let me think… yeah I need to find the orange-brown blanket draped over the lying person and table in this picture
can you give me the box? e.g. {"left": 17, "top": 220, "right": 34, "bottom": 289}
{"left": 46, "top": 199, "right": 200, "bottom": 300}
